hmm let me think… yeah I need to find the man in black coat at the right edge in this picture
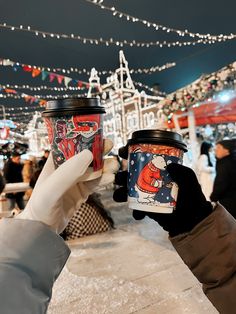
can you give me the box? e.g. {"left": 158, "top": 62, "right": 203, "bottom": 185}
{"left": 210, "top": 139, "right": 236, "bottom": 218}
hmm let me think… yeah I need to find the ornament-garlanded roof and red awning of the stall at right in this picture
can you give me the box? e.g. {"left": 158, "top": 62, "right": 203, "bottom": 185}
{"left": 159, "top": 62, "right": 236, "bottom": 128}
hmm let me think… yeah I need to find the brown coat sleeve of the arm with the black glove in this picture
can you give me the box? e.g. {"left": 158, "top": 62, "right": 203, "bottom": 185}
{"left": 170, "top": 205, "right": 236, "bottom": 314}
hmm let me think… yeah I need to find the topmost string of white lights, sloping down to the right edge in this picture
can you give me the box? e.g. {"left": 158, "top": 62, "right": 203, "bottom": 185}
{"left": 85, "top": 0, "right": 236, "bottom": 41}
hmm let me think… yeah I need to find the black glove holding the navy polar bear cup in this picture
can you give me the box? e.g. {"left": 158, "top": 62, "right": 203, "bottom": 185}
{"left": 113, "top": 154, "right": 213, "bottom": 237}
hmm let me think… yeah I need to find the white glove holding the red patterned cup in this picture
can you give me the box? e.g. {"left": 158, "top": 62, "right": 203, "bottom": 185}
{"left": 15, "top": 140, "right": 119, "bottom": 233}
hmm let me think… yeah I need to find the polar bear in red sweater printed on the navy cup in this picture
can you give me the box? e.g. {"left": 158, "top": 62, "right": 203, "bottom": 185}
{"left": 135, "top": 155, "right": 167, "bottom": 203}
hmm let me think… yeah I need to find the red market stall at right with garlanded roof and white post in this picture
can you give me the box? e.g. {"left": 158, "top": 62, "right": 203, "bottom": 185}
{"left": 155, "top": 62, "right": 236, "bottom": 168}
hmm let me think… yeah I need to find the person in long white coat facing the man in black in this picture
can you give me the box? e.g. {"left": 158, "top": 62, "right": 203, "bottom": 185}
{"left": 197, "top": 141, "right": 215, "bottom": 201}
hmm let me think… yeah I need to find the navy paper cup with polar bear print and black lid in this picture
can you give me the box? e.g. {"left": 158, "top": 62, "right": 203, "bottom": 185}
{"left": 128, "top": 130, "right": 186, "bottom": 213}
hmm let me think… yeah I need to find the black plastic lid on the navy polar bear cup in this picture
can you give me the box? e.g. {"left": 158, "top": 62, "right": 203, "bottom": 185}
{"left": 127, "top": 129, "right": 187, "bottom": 152}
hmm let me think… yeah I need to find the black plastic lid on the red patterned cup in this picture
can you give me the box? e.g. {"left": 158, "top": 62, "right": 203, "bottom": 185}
{"left": 42, "top": 97, "right": 106, "bottom": 117}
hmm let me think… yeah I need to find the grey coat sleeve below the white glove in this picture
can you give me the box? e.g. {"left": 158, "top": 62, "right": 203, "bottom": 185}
{"left": 0, "top": 218, "right": 70, "bottom": 314}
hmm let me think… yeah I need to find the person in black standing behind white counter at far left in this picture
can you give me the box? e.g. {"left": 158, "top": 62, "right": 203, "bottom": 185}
{"left": 3, "top": 152, "right": 25, "bottom": 210}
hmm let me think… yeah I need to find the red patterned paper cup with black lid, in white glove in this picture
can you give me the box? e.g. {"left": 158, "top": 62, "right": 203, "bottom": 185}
{"left": 43, "top": 98, "right": 105, "bottom": 181}
